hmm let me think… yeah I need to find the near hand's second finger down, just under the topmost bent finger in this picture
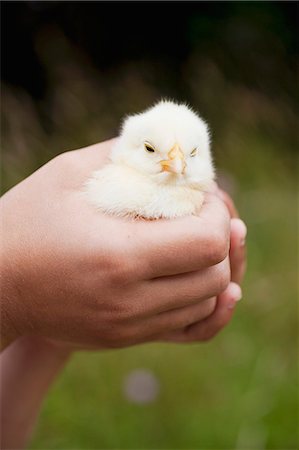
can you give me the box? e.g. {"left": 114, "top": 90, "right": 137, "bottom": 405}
{"left": 142, "top": 257, "right": 230, "bottom": 315}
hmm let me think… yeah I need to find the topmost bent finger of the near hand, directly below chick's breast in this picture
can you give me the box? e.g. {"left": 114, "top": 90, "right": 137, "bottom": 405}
{"left": 131, "top": 194, "right": 230, "bottom": 278}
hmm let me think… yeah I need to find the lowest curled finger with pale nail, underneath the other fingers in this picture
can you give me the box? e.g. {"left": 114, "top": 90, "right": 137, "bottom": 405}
{"left": 159, "top": 283, "right": 242, "bottom": 342}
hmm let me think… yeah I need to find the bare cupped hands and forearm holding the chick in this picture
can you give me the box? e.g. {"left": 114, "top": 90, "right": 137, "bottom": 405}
{"left": 1, "top": 141, "right": 246, "bottom": 448}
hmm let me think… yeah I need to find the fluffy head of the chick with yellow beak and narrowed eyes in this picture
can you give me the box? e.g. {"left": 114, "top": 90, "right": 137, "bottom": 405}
{"left": 112, "top": 101, "right": 214, "bottom": 184}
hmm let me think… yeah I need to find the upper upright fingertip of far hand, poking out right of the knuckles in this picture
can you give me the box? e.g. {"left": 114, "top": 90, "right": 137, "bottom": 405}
{"left": 230, "top": 219, "right": 247, "bottom": 284}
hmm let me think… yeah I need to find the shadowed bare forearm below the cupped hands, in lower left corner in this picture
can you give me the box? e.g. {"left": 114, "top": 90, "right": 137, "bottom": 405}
{"left": 1, "top": 337, "right": 69, "bottom": 449}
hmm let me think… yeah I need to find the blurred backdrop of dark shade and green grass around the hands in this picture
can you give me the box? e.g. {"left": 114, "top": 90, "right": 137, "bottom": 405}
{"left": 1, "top": 2, "right": 299, "bottom": 450}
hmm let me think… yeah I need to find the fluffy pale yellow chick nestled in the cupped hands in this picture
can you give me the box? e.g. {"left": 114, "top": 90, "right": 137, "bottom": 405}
{"left": 85, "top": 101, "right": 214, "bottom": 219}
